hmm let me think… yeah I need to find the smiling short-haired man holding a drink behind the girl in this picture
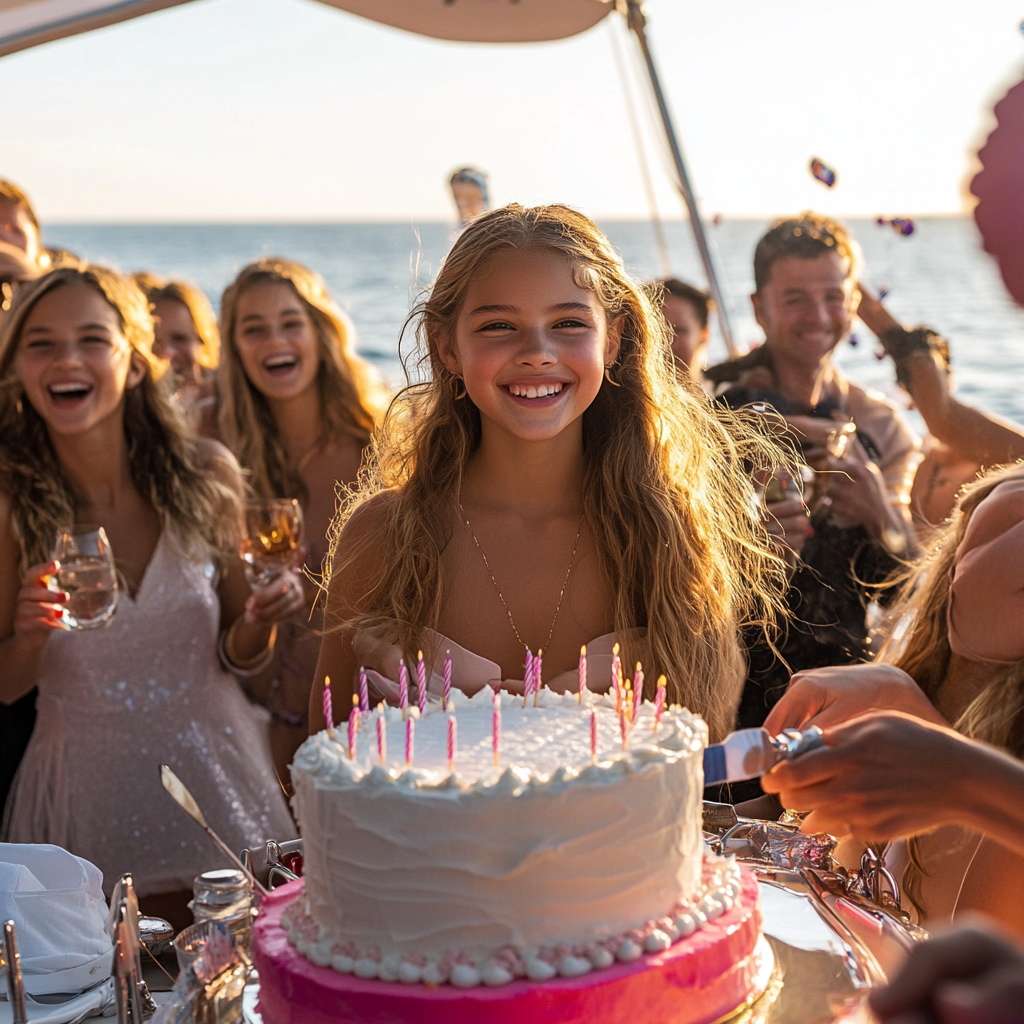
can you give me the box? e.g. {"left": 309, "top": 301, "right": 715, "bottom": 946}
{"left": 706, "top": 213, "right": 920, "bottom": 774}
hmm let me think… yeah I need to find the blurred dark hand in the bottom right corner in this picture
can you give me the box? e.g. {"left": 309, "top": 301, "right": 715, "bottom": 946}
{"left": 867, "top": 920, "right": 1024, "bottom": 1024}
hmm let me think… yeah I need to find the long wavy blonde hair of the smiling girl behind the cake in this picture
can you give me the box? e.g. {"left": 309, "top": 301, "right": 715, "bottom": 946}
{"left": 328, "top": 205, "right": 787, "bottom": 737}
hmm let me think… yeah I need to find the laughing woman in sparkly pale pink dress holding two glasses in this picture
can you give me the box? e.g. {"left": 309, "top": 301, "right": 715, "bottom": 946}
{"left": 0, "top": 264, "right": 303, "bottom": 921}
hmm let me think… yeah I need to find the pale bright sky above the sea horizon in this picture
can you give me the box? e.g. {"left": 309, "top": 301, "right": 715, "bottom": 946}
{"left": 0, "top": 0, "right": 1024, "bottom": 222}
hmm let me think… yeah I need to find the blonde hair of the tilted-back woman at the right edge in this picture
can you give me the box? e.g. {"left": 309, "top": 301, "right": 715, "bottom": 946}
{"left": 879, "top": 465, "right": 1024, "bottom": 910}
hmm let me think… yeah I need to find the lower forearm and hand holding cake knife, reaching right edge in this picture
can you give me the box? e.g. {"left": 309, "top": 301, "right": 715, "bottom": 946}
{"left": 761, "top": 713, "right": 1024, "bottom": 855}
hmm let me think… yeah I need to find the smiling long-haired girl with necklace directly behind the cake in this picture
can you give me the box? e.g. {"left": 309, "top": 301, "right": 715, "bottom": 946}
{"left": 309, "top": 205, "right": 785, "bottom": 738}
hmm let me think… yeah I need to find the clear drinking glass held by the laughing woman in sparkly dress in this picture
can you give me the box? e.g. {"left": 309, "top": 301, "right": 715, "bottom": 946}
{"left": 53, "top": 525, "right": 118, "bottom": 630}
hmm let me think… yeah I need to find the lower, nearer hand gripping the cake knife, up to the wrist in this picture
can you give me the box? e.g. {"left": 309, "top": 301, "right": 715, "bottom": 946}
{"left": 761, "top": 712, "right": 970, "bottom": 841}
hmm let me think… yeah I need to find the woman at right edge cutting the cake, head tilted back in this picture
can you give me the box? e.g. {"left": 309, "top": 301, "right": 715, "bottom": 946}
{"left": 763, "top": 466, "right": 1024, "bottom": 935}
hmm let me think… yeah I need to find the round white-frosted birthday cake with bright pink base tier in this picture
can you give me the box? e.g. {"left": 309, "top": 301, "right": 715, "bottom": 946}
{"left": 253, "top": 688, "right": 771, "bottom": 1024}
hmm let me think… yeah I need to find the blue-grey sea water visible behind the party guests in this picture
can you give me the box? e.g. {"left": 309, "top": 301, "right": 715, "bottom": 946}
{"left": 45, "top": 217, "right": 1024, "bottom": 424}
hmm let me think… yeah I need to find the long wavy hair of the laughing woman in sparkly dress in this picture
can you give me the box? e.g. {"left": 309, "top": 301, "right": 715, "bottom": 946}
{"left": 0, "top": 263, "right": 240, "bottom": 572}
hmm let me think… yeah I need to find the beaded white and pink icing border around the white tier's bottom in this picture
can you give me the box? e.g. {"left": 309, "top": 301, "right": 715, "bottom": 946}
{"left": 281, "top": 857, "right": 742, "bottom": 988}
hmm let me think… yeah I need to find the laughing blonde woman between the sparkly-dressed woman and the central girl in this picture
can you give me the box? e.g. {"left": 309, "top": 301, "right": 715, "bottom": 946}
{"left": 206, "top": 256, "right": 387, "bottom": 778}
